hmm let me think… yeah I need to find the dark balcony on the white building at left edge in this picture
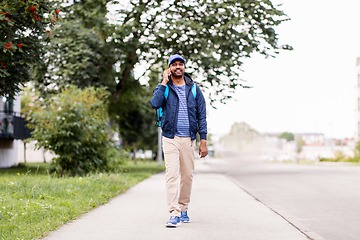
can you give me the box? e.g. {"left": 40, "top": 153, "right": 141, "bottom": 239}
{"left": 0, "top": 111, "right": 31, "bottom": 139}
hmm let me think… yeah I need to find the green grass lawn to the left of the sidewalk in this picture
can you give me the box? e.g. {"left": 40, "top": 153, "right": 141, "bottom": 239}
{"left": 0, "top": 162, "right": 164, "bottom": 240}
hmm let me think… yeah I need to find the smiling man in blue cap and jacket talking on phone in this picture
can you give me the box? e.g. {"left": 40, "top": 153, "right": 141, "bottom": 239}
{"left": 150, "top": 54, "right": 208, "bottom": 227}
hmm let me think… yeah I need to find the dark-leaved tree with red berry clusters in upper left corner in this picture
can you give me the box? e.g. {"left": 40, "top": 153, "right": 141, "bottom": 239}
{"left": 0, "top": 0, "right": 60, "bottom": 96}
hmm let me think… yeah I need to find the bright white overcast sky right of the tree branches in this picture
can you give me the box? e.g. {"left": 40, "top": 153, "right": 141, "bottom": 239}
{"left": 207, "top": 0, "right": 360, "bottom": 138}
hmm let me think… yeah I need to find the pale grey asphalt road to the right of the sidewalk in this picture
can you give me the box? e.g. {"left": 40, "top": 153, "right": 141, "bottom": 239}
{"left": 206, "top": 157, "right": 360, "bottom": 240}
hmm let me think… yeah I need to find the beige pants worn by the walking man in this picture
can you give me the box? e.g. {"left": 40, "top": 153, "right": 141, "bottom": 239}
{"left": 162, "top": 136, "right": 196, "bottom": 217}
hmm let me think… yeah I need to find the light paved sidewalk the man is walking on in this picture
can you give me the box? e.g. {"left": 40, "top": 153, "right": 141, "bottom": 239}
{"left": 44, "top": 160, "right": 308, "bottom": 240}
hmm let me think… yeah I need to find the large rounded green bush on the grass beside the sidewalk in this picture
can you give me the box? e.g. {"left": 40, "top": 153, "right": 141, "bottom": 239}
{"left": 31, "top": 86, "right": 119, "bottom": 176}
